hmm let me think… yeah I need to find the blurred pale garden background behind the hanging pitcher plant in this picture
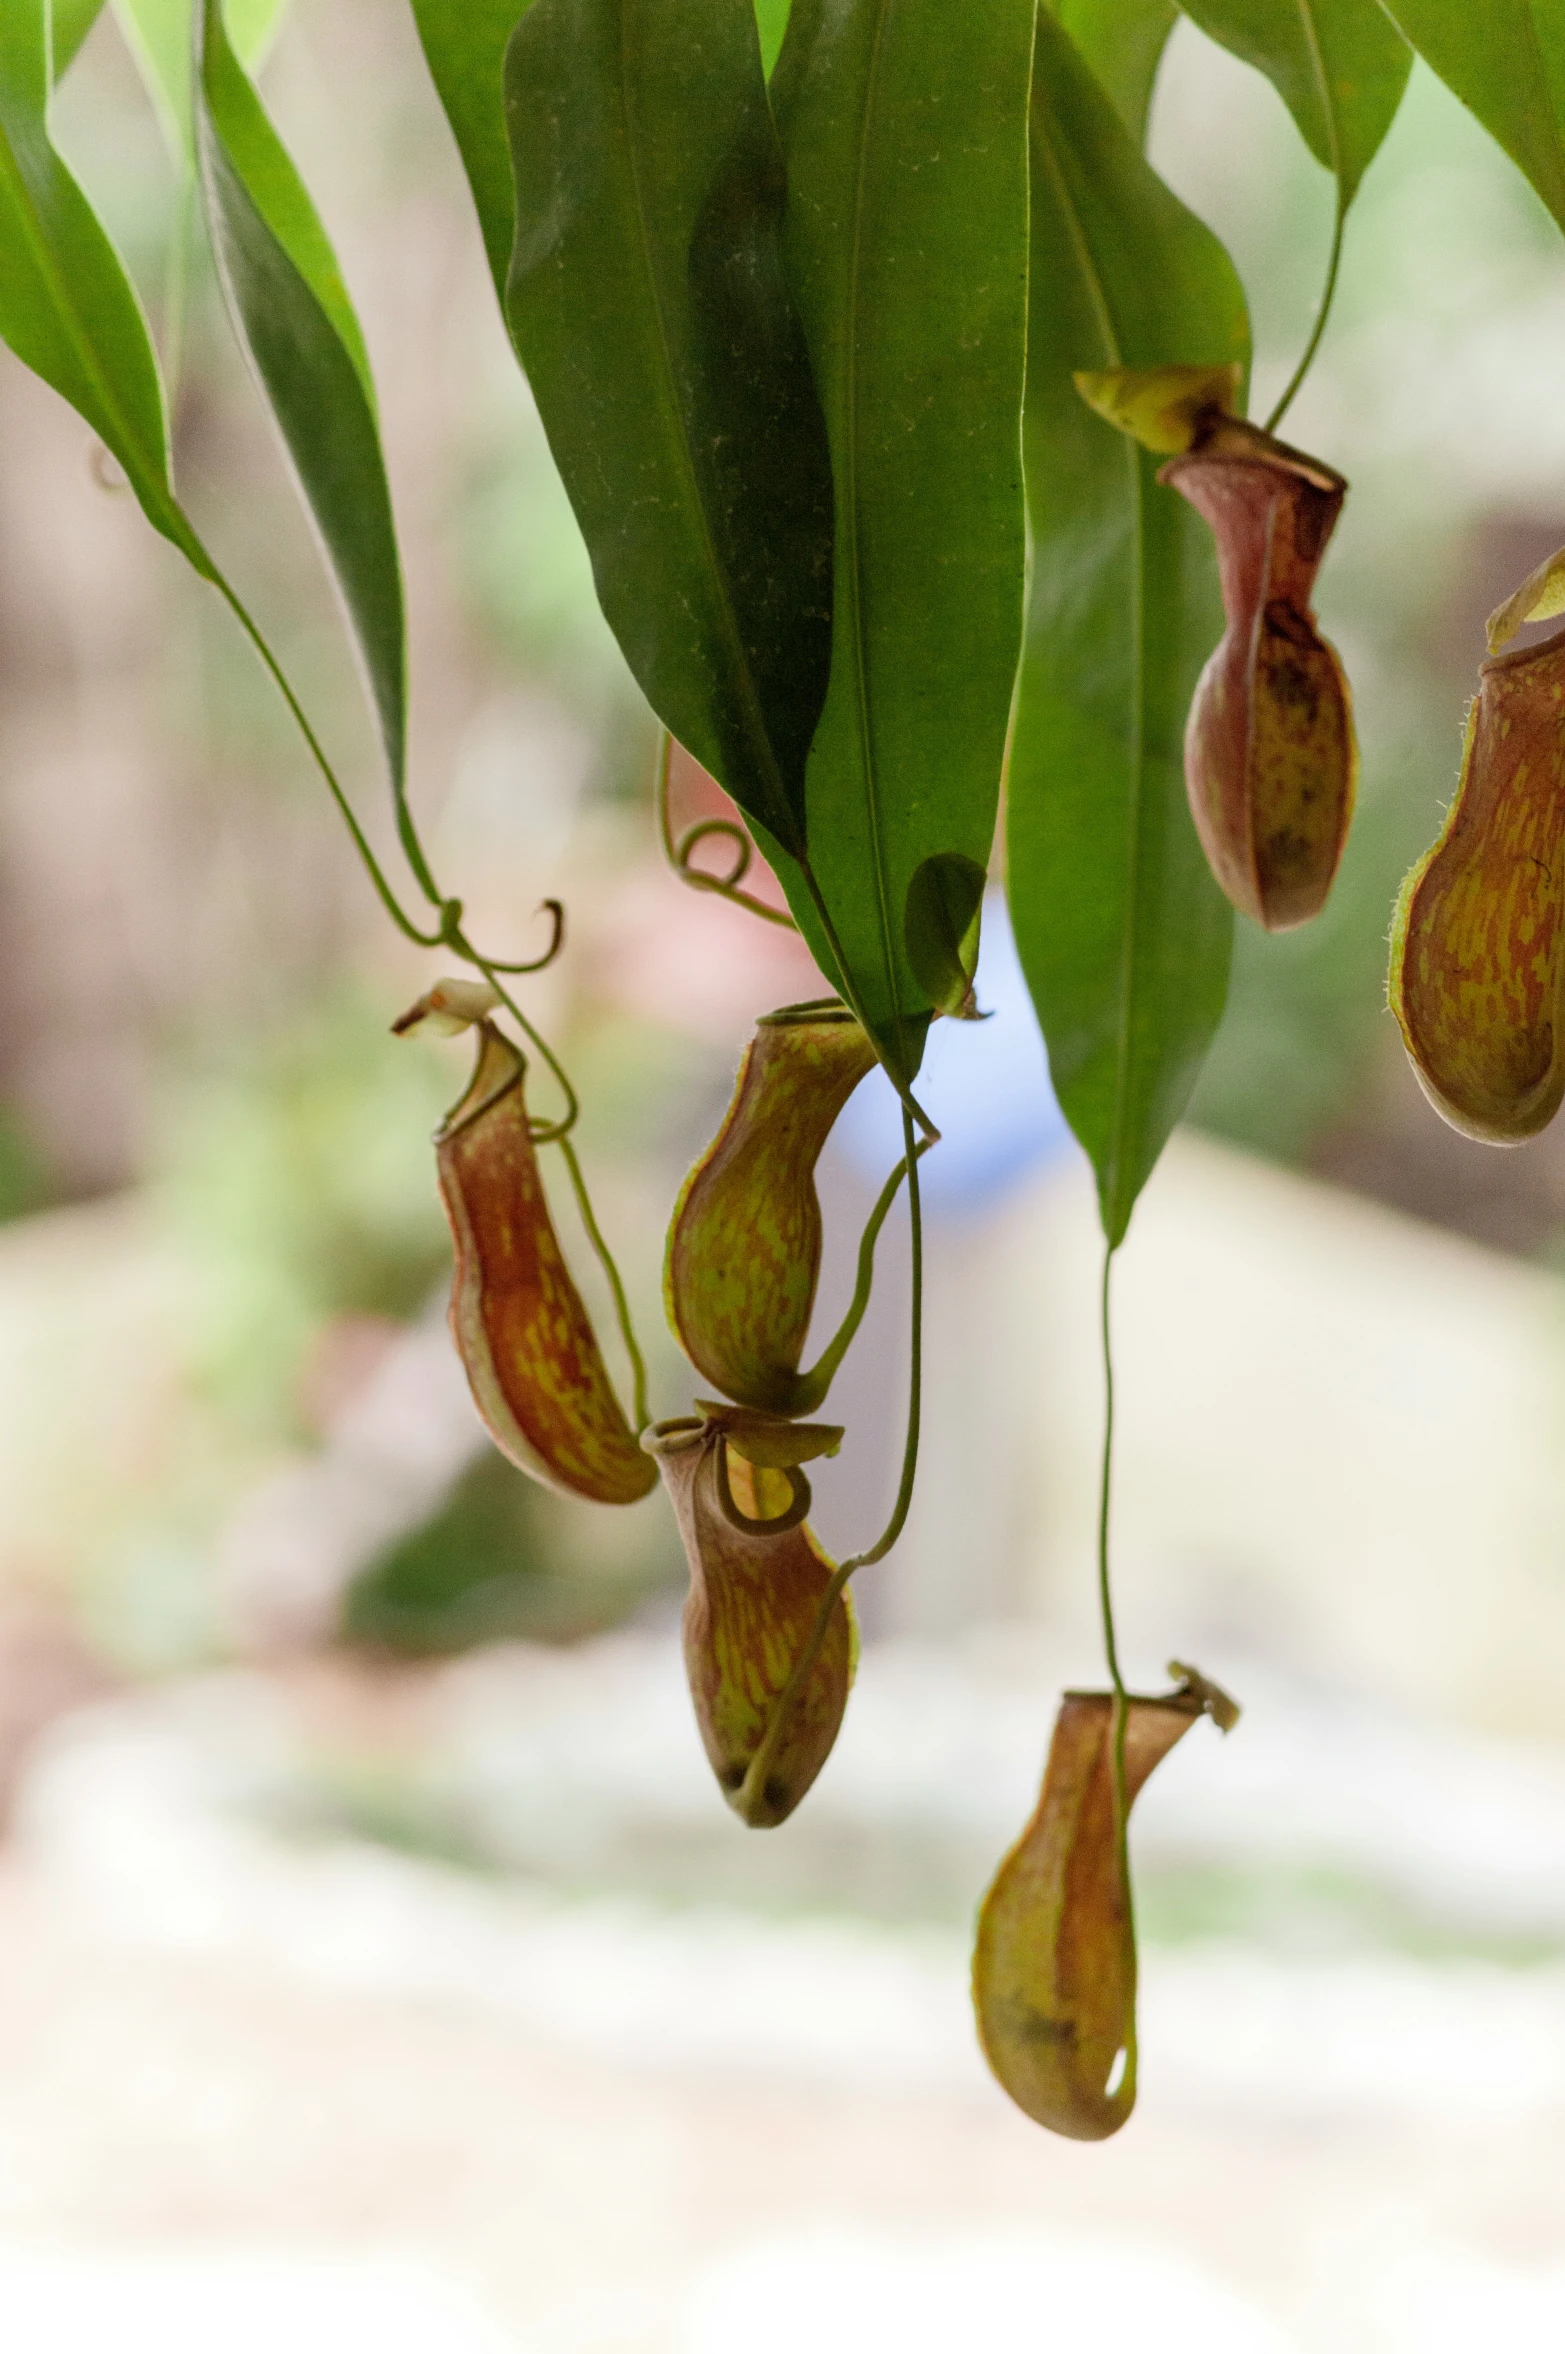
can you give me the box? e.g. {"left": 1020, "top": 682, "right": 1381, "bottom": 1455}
{"left": 0, "top": 0, "right": 1565, "bottom": 2354}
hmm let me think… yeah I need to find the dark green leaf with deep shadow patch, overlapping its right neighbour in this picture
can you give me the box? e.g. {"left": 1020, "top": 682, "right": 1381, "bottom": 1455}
{"left": 506, "top": 0, "right": 837, "bottom": 855}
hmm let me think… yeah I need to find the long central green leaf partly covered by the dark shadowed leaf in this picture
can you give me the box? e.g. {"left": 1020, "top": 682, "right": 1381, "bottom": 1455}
{"left": 772, "top": 0, "right": 1033, "bottom": 1080}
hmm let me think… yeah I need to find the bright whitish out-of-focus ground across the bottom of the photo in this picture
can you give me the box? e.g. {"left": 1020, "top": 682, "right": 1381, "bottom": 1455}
{"left": 0, "top": 1638, "right": 1565, "bottom": 2354}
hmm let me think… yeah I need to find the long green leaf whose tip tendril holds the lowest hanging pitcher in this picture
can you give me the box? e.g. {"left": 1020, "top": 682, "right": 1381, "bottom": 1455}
{"left": 1007, "top": 16, "right": 1250, "bottom": 1243}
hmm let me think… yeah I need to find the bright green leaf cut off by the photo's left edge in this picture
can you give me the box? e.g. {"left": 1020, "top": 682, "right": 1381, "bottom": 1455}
{"left": 0, "top": 0, "right": 214, "bottom": 579}
